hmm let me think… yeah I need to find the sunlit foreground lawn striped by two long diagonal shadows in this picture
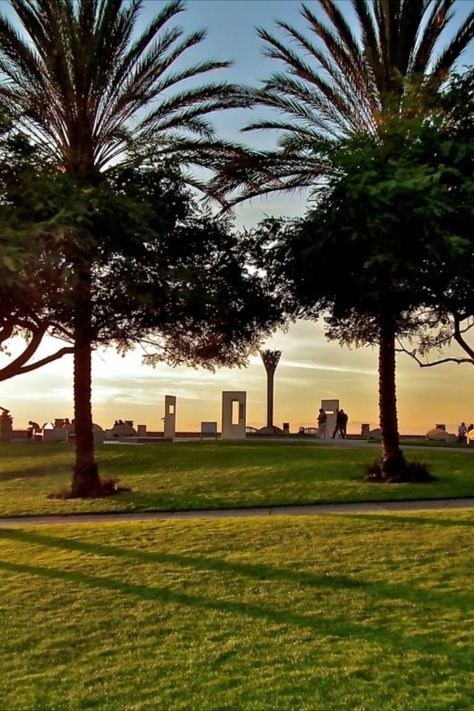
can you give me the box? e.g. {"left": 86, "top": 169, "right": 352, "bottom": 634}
{"left": 0, "top": 511, "right": 474, "bottom": 711}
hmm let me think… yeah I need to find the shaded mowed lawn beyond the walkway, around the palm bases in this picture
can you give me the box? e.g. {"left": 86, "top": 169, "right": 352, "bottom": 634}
{"left": 0, "top": 442, "right": 474, "bottom": 516}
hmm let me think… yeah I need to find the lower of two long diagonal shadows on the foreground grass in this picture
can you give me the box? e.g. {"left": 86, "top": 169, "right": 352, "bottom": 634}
{"left": 0, "top": 560, "right": 472, "bottom": 671}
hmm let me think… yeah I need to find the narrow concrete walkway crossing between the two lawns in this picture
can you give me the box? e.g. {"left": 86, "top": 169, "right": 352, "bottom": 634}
{"left": 0, "top": 498, "right": 474, "bottom": 528}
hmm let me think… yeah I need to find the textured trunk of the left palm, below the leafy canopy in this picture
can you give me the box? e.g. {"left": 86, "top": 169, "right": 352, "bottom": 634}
{"left": 72, "top": 264, "right": 101, "bottom": 497}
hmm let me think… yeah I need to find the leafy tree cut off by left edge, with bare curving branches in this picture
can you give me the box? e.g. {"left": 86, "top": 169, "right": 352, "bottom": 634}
{"left": 0, "top": 122, "right": 73, "bottom": 381}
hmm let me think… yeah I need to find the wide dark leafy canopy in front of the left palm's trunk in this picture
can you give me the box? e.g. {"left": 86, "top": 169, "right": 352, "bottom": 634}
{"left": 0, "top": 155, "right": 276, "bottom": 495}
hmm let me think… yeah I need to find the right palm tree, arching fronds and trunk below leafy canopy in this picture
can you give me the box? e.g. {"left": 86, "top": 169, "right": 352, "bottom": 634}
{"left": 215, "top": 0, "right": 474, "bottom": 478}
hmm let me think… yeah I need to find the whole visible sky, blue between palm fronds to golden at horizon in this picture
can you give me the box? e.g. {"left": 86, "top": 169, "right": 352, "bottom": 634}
{"left": 0, "top": 0, "right": 474, "bottom": 434}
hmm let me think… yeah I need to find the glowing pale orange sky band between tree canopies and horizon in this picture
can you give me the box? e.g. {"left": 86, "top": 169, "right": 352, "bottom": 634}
{"left": 0, "top": 322, "right": 474, "bottom": 434}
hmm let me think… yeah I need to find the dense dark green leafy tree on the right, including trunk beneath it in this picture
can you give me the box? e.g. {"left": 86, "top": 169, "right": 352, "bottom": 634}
{"left": 253, "top": 114, "right": 463, "bottom": 477}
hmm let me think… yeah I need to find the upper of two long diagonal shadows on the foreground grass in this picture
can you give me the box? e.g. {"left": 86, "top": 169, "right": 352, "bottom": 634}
{"left": 0, "top": 517, "right": 474, "bottom": 612}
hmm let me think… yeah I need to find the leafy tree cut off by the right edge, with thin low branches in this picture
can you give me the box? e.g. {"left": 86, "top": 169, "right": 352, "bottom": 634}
{"left": 399, "top": 69, "right": 474, "bottom": 367}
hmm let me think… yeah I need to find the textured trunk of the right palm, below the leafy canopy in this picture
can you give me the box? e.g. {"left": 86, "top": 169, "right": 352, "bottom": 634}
{"left": 379, "top": 322, "right": 406, "bottom": 478}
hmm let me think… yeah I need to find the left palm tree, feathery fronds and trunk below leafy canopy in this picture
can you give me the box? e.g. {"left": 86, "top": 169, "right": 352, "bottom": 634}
{"left": 0, "top": 0, "right": 243, "bottom": 496}
